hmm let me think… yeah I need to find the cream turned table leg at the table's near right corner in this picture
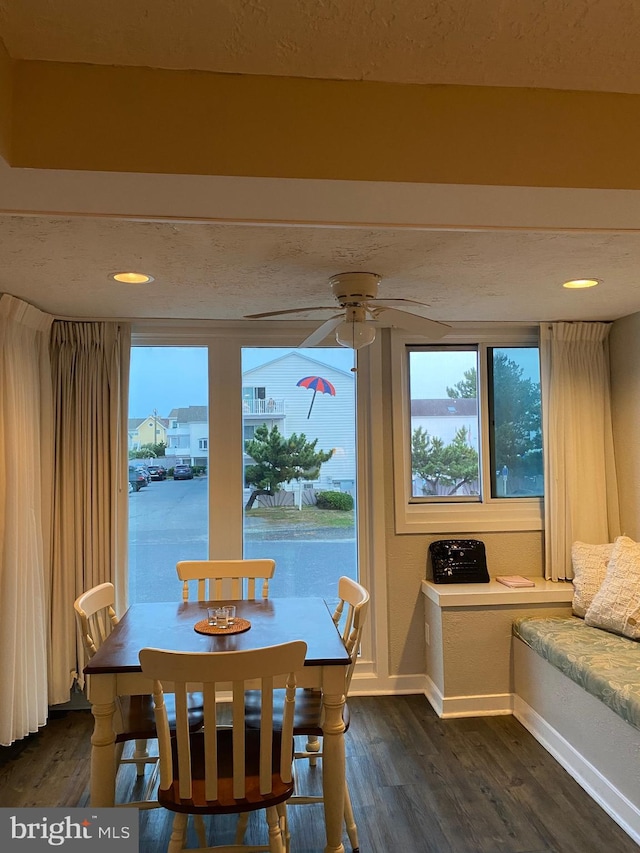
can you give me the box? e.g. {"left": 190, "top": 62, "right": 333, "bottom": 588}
{"left": 322, "top": 693, "right": 345, "bottom": 853}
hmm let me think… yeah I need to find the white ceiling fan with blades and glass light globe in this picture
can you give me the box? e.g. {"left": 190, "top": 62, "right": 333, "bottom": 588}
{"left": 245, "top": 272, "right": 450, "bottom": 349}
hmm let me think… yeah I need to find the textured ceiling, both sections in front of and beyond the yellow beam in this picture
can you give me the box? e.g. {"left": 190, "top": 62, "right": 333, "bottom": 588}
{"left": 0, "top": 0, "right": 640, "bottom": 321}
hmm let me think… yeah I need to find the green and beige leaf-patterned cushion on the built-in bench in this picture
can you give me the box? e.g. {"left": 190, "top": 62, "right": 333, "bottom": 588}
{"left": 513, "top": 616, "right": 640, "bottom": 729}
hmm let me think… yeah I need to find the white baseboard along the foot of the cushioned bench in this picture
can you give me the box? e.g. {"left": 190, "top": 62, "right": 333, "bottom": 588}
{"left": 513, "top": 696, "right": 640, "bottom": 844}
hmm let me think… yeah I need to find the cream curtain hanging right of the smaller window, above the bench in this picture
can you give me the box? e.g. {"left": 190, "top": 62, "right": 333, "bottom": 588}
{"left": 540, "top": 323, "right": 620, "bottom": 580}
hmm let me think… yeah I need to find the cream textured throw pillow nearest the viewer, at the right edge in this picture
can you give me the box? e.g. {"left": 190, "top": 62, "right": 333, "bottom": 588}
{"left": 584, "top": 536, "right": 640, "bottom": 640}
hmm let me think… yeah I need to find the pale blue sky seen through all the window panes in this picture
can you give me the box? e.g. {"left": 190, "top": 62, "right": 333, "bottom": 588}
{"left": 129, "top": 347, "right": 539, "bottom": 418}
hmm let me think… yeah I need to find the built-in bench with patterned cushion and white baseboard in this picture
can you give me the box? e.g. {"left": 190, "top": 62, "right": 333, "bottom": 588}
{"left": 513, "top": 616, "right": 640, "bottom": 843}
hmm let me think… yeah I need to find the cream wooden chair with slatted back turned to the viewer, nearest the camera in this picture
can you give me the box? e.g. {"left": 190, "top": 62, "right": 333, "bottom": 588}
{"left": 140, "top": 640, "right": 307, "bottom": 853}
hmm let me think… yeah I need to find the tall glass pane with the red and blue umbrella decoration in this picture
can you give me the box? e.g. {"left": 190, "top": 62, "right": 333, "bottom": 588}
{"left": 242, "top": 347, "right": 358, "bottom": 598}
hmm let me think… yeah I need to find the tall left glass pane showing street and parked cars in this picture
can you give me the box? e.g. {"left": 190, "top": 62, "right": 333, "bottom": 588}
{"left": 128, "top": 346, "right": 209, "bottom": 604}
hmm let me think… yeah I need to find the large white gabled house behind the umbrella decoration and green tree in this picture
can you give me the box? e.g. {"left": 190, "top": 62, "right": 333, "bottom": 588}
{"left": 242, "top": 352, "right": 356, "bottom": 491}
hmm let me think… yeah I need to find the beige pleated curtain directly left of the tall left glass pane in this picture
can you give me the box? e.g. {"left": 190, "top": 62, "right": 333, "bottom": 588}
{"left": 49, "top": 321, "right": 131, "bottom": 705}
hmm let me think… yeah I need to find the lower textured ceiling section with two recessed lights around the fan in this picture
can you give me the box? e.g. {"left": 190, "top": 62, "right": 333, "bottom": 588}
{"left": 5, "top": 217, "right": 640, "bottom": 321}
